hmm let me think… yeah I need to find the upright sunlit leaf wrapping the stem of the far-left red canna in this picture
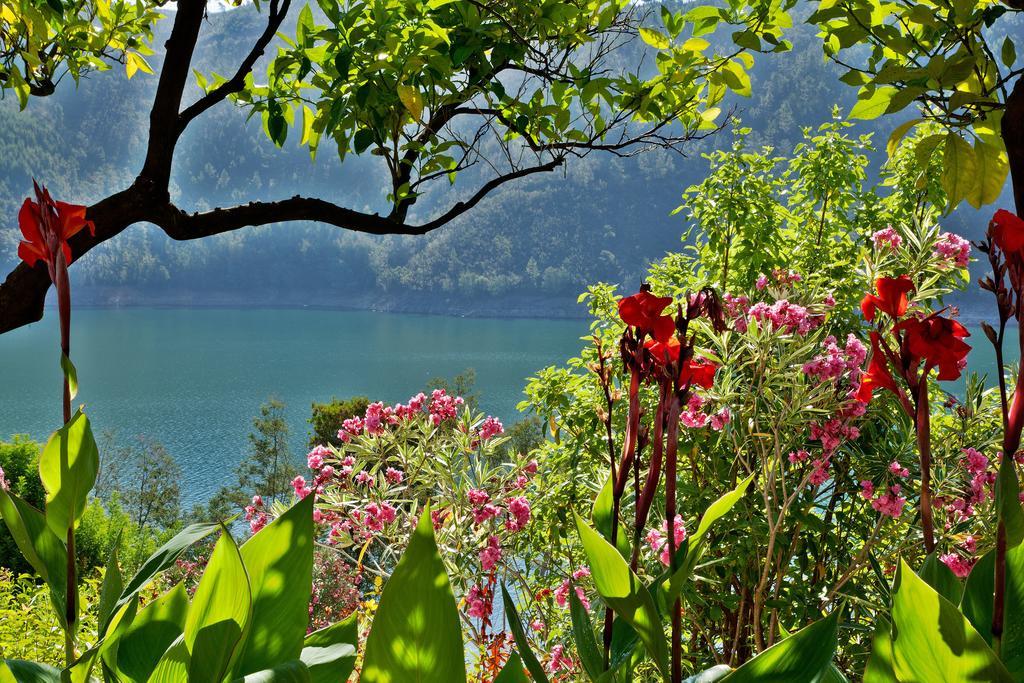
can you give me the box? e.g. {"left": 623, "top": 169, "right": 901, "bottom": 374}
{"left": 39, "top": 411, "right": 99, "bottom": 539}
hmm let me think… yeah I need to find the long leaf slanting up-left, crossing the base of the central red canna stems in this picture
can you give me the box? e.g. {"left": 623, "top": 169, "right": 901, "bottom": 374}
{"left": 575, "top": 514, "right": 669, "bottom": 677}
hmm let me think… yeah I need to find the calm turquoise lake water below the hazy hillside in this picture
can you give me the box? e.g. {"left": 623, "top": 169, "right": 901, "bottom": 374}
{"left": 0, "top": 308, "right": 587, "bottom": 503}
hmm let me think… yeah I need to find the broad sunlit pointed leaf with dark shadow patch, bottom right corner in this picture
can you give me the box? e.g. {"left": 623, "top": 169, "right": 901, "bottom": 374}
{"left": 892, "top": 560, "right": 1013, "bottom": 683}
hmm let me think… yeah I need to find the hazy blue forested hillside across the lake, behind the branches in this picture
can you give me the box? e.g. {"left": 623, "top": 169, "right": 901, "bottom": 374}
{"left": 0, "top": 3, "right": 1007, "bottom": 315}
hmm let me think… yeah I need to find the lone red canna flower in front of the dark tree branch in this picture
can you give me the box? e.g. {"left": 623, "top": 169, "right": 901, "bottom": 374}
{"left": 17, "top": 182, "right": 96, "bottom": 279}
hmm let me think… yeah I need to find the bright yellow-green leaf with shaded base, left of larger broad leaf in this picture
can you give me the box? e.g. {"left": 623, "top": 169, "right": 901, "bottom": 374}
{"left": 184, "top": 527, "right": 253, "bottom": 681}
